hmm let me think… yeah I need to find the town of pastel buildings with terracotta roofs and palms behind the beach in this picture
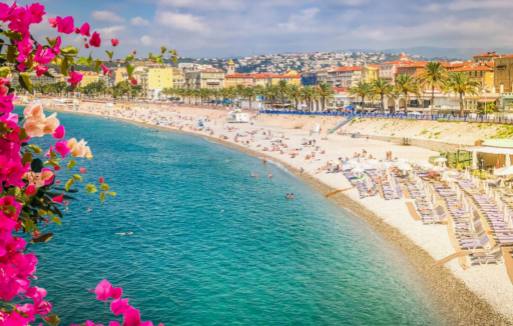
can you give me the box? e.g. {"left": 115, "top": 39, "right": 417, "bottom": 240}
{"left": 20, "top": 51, "right": 513, "bottom": 113}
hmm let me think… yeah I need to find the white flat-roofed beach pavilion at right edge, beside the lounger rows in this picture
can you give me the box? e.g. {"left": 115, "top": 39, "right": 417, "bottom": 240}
{"left": 468, "top": 139, "right": 513, "bottom": 169}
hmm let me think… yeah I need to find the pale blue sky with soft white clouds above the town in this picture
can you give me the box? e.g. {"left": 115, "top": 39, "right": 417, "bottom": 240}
{"left": 12, "top": 0, "right": 513, "bottom": 57}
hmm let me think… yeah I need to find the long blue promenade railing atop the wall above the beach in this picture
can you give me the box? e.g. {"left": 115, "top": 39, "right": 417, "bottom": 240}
{"left": 259, "top": 110, "right": 513, "bottom": 125}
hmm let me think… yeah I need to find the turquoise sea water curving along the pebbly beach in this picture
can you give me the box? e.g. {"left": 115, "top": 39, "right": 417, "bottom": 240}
{"left": 34, "top": 114, "right": 441, "bottom": 325}
